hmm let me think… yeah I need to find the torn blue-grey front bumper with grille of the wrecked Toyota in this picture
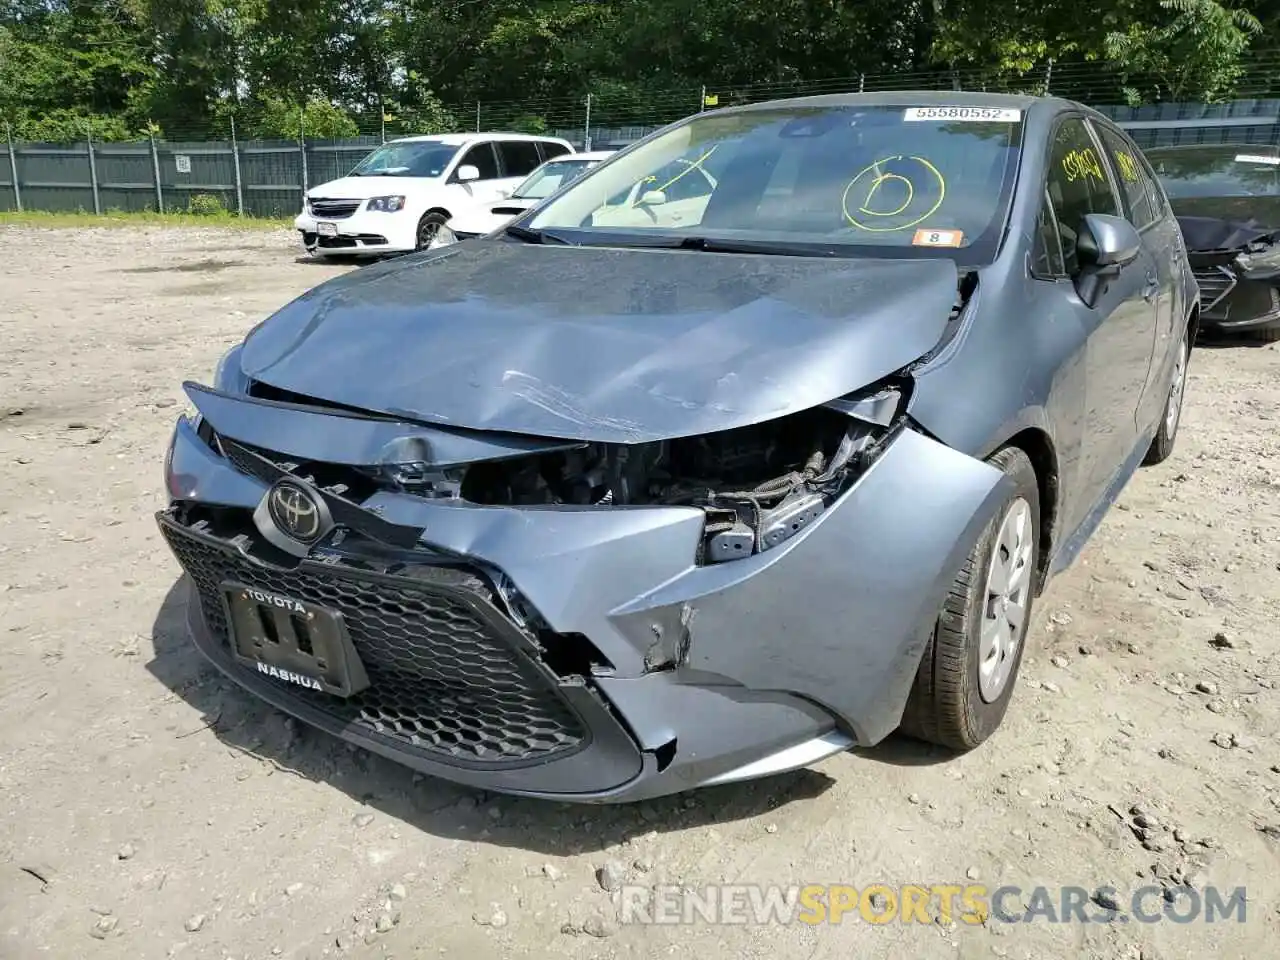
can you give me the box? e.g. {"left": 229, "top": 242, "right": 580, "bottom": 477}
{"left": 159, "top": 378, "right": 1007, "bottom": 801}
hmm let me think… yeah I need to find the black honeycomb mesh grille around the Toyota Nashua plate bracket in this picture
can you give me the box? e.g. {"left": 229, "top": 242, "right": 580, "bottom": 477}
{"left": 161, "top": 522, "right": 585, "bottom": 765}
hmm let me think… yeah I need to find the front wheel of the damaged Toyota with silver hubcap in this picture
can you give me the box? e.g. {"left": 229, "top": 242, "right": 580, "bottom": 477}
{"left": 901, "top": 447, "right": 1041, "bottom": 750}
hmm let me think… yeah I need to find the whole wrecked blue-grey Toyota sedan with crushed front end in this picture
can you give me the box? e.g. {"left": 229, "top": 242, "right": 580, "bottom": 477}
{"left": 159, "top": 93, "right": 1197, "bottom": 801}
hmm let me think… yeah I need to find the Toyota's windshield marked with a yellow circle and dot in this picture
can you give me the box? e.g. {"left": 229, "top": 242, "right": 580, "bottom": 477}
{"left": 526, "top": 105, "right": 1021, "bottom": 262}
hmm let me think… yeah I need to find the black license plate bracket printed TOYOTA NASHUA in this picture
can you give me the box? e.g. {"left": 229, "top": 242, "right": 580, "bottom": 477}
{"left": 221, "top": 581, "right": 369, "bottom": 698}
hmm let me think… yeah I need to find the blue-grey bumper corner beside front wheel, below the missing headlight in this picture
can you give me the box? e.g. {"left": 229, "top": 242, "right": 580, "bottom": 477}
{"left": 613, "top": 429, "right": 1011, "bottom": 745}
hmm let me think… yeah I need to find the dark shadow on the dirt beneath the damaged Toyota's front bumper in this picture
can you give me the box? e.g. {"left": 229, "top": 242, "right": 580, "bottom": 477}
{"left": 147, "top": 579, "right": 835, "bottom": 856}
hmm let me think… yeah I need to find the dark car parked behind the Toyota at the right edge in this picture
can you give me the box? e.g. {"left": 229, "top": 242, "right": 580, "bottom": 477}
{"left": 1146, "top": 143, "right": 1280, "bottom": 342}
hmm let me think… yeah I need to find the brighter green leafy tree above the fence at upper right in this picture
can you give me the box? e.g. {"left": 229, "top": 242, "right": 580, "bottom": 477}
{"left": 1106, "top": 0, "right": 1262, "bottom": 104}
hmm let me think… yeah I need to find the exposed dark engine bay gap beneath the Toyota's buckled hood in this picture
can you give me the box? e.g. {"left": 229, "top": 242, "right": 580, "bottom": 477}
{"left": 215, "top": 383, "right": 902, "bottom": 563}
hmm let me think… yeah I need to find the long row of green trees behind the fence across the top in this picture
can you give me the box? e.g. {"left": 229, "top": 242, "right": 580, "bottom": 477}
{"left": 0, "top": 0, "right": 1280, "bottom": 141}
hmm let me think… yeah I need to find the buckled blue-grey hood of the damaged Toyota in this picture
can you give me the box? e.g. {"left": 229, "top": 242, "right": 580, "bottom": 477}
{"left": 241, "top": 241, "right": 957, "bottom": 443}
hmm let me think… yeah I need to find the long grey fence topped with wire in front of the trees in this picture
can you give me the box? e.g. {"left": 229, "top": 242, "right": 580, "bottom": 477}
{"left": 0, "top": 55, "right": 1280, "bottom": 216}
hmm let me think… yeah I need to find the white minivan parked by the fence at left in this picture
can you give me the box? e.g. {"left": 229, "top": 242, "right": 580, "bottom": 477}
{"left": 293, "top": 133, "right": 573, "bottom": 256}
